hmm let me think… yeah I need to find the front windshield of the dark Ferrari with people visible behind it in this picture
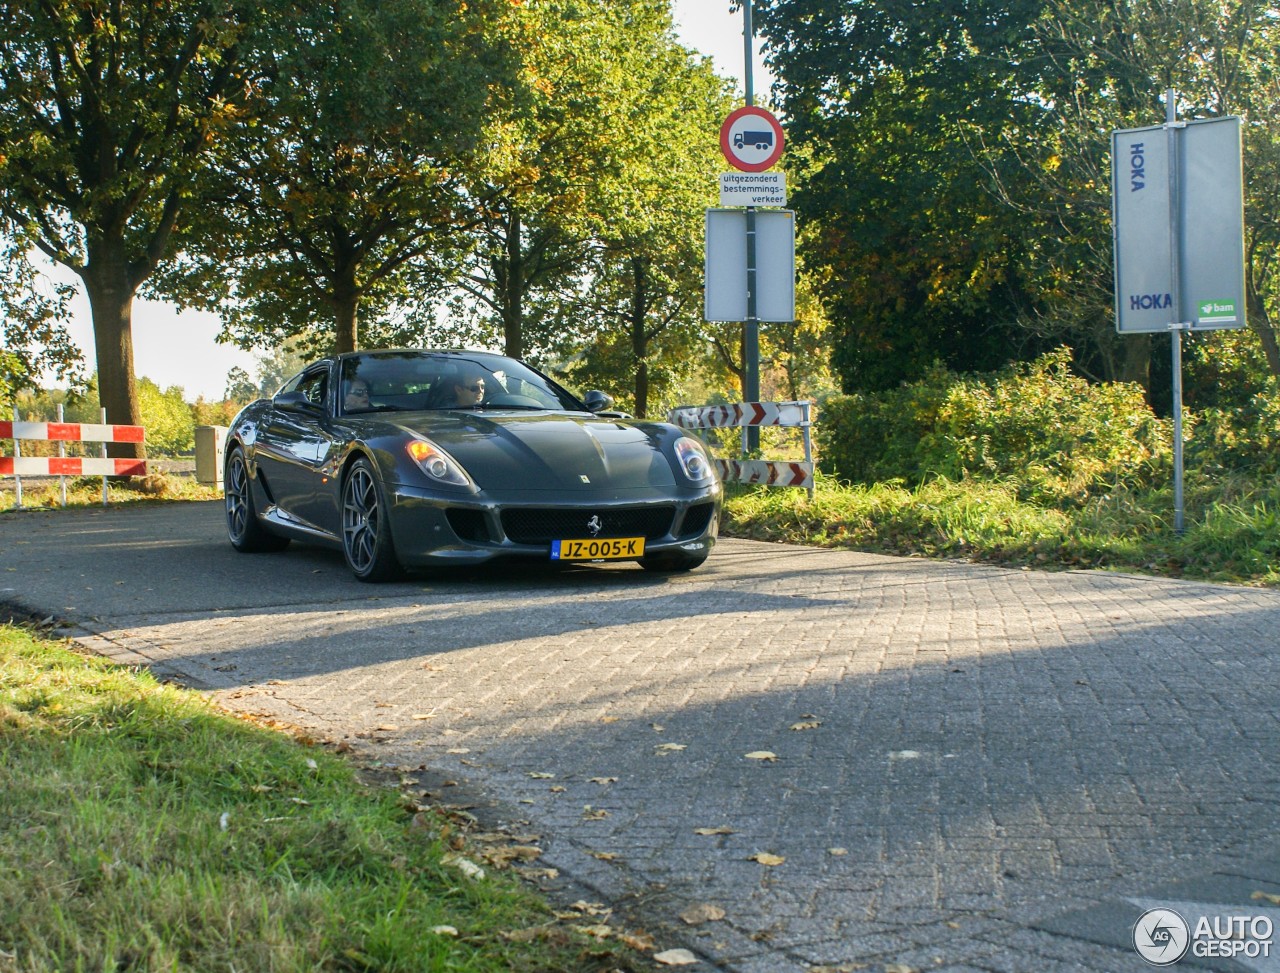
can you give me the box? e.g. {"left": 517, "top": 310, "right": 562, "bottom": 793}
{"left": 342, "top": 351, "right": 585, "bottom": 415}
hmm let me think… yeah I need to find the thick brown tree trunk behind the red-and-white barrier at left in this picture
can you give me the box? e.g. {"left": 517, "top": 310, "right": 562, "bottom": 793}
{"left": 78, "top": 239, "right": 147, "bottom": 458}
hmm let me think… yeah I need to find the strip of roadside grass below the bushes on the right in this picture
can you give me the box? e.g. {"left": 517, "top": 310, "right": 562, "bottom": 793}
{"left": 722, "top": 475, "right": 1280, "bottom": 585}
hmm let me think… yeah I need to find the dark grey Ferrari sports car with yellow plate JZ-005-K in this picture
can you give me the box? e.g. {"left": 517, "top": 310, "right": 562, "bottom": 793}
{"left": 224, "top": 350, "right": 722, "bottom": 581}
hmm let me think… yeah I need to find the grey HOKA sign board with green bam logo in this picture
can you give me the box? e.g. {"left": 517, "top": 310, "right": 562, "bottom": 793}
{"left": 1111, "top": 117, "right": 1245, "bottom": 334}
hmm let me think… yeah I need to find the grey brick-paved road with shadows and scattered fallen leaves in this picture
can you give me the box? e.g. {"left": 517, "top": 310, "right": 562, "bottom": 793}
{"left": 0, "top": 504, "right": 1280, "bottom": 973}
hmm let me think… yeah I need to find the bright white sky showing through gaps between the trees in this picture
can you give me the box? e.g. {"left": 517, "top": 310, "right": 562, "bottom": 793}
{"left": 47, "top": 0, "right": 771, "bottom": 401}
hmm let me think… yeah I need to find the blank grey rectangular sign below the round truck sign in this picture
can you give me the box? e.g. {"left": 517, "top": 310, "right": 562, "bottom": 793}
{"left": 703, "top": 210, "right": 796, "bottom": 321}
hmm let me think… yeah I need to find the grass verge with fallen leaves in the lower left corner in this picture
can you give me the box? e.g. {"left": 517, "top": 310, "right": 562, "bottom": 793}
{"left": 0, "top": 625, "right": 635, "bottom": 973}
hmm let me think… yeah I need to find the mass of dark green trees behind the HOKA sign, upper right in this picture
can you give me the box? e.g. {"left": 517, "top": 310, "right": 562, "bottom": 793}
{"left": 758, "top": 0, "right": 1280, "bottom": 390}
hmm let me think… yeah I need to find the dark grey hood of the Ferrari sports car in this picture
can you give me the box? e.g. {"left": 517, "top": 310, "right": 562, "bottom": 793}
{"left": 384, "top": 411, "right": 676, "bottom": 494}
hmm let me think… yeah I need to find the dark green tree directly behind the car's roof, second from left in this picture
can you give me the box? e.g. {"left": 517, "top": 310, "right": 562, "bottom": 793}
{"left": 163, "top": 0, "right": 513, "bottom": 352}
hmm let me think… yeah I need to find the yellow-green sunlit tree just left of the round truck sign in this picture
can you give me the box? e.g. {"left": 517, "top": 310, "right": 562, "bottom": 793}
{"left": 454, "top": 0, "right": 722, "bottom": 358}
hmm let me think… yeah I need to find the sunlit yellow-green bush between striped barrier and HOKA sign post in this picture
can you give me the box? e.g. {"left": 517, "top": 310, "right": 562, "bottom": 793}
{"left": 818, "top": 348, "right": 1171, "bottom": 502}
